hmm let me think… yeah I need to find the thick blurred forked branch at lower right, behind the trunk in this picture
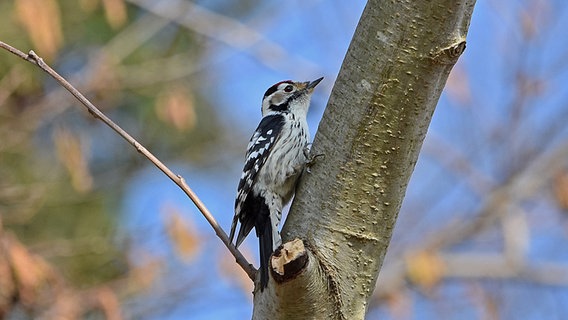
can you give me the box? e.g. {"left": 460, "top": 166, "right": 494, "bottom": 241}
{"left": 375, "top": 136, "right": 568, "bottom": 298}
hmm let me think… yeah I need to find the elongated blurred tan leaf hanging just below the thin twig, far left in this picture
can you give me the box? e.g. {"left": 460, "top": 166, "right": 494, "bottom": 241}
{"left": 53, "top": 128, "right": 93, "bottom": 192}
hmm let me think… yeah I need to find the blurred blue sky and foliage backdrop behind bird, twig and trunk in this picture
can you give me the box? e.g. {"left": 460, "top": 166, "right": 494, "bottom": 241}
{"left": 0, "top": 0, "right": 568, "bottom": 319}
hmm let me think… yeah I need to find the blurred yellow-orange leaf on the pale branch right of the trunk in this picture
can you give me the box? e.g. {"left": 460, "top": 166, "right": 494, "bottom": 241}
{"left": 406, "top": 251, "right": 445, "bottom": 291}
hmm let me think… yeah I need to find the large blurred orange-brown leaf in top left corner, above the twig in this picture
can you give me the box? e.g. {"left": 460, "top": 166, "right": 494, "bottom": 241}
{"left": 15, "top": 0, "right": 63, "bottom": 60}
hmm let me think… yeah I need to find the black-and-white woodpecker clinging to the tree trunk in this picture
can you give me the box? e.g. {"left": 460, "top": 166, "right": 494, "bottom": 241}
{"left": 229, "top": 77, "right": 323, "bottom": 291}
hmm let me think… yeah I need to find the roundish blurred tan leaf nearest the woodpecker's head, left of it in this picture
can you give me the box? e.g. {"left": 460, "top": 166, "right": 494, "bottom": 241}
{"left": 156, "top": 85, "right": 197, "bottom": 132}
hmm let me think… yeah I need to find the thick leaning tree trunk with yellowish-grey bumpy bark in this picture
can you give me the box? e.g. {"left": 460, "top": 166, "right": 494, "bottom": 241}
{"left": 253, "top": 0, "right": 475, "bottom": 319}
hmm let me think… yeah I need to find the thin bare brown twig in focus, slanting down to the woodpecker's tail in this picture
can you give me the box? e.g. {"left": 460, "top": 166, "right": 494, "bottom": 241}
{"left": 0, "top": 41, "right": 256, "bottom": 281}
